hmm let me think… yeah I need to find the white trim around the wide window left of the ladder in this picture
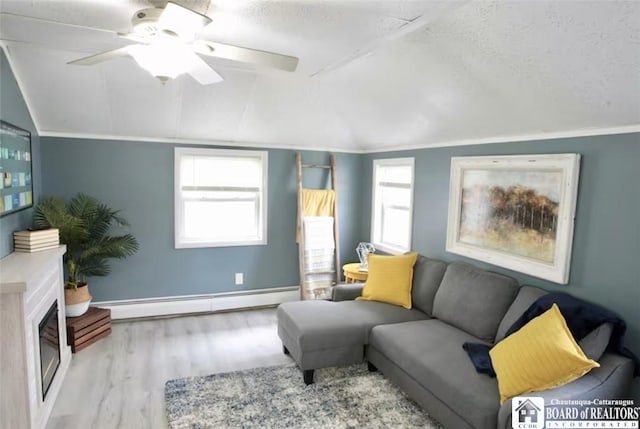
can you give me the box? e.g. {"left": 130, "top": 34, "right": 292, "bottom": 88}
{"left": 173, "top": 147, "right": 269, "bottom": 249}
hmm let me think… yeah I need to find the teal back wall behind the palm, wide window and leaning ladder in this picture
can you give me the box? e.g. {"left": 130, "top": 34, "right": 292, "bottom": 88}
{"left": 42, "top": 137, "right": 361, "bottom": 301}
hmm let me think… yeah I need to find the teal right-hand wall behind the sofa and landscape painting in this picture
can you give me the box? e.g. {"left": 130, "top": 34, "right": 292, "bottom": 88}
{"left": 360, "top": 134, "right": 640, "bottom": 362}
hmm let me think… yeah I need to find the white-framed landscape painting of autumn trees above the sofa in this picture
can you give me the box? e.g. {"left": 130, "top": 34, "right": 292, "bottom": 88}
{"left": 447, "top": 154, "right": 580, "bottom": 284}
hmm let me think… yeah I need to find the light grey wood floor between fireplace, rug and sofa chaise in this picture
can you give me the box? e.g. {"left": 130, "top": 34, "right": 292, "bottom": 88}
{"left": 47, "top": 308, "right": 292, "bottom": 429}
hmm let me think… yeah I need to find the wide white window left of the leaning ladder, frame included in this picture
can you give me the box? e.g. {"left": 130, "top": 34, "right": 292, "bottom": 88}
{"left": 175, "top": 148, "right": 268, "bottom": 248}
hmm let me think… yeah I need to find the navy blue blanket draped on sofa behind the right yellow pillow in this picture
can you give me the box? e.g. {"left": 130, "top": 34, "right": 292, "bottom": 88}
{"left": 462, "top": 292, "right": 640, "bottom": 377}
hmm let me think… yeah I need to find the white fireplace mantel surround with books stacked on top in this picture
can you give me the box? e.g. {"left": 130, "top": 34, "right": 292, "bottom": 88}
{"left": 0, "top": 246, "right": 71, "bottom": 429}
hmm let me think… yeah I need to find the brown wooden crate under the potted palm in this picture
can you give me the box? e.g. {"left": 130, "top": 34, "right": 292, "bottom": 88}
{"left": 67, "top": 307, "right": 111, "bottom": 353}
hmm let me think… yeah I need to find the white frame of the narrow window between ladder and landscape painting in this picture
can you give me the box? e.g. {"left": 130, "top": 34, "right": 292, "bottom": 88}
{"left": 371, "top": 157, "right": 415, "bottom": 255}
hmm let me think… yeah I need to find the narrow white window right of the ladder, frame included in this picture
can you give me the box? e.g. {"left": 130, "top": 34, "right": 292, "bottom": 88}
{"left": 371, "top": 158, "right": 413, "bottom": 254}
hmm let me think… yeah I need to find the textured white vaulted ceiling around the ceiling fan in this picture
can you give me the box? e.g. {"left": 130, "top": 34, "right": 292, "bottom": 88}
{"left": 0, "top": 0, "right": 640, "bottom": 150}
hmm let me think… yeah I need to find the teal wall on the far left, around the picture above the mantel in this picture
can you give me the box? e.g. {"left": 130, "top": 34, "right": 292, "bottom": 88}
{"left": 0, "top": 49, "right": 42, "bottom": 258}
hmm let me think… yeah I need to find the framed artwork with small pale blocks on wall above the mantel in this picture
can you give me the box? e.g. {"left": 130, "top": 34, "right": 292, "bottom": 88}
{"left": 0, "top": 121, "right": 33, "bottom": 217}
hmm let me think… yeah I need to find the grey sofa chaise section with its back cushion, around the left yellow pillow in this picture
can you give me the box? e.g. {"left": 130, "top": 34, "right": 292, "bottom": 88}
{"left": 276, "top": 256, "right": 447, "bottom": 384}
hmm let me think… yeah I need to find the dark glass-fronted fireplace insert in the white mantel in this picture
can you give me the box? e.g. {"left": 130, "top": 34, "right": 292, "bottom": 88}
{"left": 38, "top": 300, "right": 60, "bottom": 401}
